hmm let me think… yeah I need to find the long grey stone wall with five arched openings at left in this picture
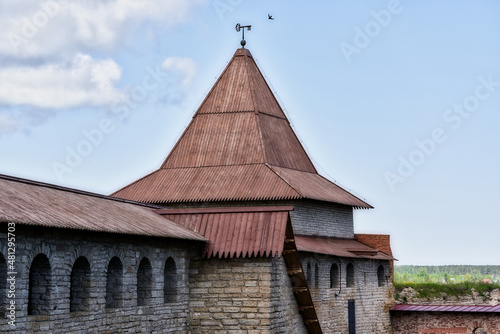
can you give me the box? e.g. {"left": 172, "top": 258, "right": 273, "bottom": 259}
{"left": 0, "top": 224, "right": 198, "bottom": 334}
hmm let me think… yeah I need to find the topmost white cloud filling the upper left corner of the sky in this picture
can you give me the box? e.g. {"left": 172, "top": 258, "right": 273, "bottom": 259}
{"left": 0, "top": 0, "right": 206, "bottom": 59}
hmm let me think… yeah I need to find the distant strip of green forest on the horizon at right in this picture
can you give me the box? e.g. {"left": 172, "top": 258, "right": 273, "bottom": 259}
{"left": 394, "top": 265, "right": 500, "bottom": 283}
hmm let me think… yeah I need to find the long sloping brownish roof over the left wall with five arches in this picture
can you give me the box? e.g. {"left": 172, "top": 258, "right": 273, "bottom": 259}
{"left": 0, "top": 175, "right": 205, "bottom": 241}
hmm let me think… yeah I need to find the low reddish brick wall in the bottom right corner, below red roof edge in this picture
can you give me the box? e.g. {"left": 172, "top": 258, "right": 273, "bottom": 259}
{"left": 391, "top": 311, "right": 500, "bottom": 334}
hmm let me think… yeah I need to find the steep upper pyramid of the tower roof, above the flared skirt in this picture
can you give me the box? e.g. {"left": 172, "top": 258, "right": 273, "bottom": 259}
{"left": 161, "top": 49, "right": 316, "bottom": 172}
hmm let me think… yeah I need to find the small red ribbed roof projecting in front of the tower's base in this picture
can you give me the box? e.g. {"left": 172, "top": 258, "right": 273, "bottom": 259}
{"left": 156, "top": 206, "right": 293, "bottom": 258}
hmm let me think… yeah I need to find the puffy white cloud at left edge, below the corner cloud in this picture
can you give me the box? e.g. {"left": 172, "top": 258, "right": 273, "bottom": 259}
{"left": 0, "top": 54, "right": 124, "bottom": 108}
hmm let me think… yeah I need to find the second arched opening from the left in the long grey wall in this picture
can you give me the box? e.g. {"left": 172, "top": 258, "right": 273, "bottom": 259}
{"left": 69, "top": 256, "right": 90, "bottom": 312}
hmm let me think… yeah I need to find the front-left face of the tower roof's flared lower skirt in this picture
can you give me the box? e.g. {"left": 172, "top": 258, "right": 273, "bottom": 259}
{"left": 115, "top": 164, "right": 301, "bottom": 203}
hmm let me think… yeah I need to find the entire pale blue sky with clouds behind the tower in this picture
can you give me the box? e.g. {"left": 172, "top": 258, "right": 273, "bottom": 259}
{"left": 0, "top": 0, "right": 500, "bottom": 265}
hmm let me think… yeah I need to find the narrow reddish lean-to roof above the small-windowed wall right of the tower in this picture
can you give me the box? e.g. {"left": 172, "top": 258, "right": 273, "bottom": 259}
{"left": 295, "top": 235, "right": 394, "bottom": 260}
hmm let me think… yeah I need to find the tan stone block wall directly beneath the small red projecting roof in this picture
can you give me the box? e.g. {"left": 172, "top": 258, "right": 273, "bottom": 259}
{"left": 189, "top": 258, "right": 306, "bottom": 334}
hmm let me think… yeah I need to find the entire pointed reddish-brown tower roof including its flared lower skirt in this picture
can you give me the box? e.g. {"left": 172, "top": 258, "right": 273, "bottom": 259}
{"left": 113, "top": 48, "right": 371, "bottom": 208}
